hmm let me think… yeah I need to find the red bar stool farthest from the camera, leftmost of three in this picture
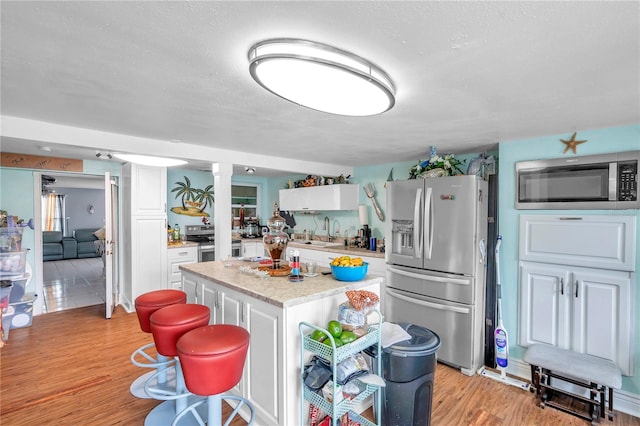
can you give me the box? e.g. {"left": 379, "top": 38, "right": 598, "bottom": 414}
{"left": 129, "top": 290, "right": 187, "bottom": 398}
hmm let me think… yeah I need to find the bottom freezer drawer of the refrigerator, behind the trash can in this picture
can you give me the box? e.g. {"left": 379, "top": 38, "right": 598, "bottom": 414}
{"left": 385, "top": 287, "right": 482, "bottom": 375}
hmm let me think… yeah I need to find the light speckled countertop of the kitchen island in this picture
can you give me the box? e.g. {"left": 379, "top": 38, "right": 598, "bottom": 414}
{"left": 180, "top": 260, "right": 383, "bottom": 307}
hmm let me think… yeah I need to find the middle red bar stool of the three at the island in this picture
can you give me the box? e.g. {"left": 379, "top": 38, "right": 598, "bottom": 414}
{"left": 144, "top": 303, "right": 210, "bottom": 426}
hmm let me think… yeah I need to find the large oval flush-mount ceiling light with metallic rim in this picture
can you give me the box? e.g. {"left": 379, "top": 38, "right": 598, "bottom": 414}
{"left": 249, "top": 38, "right": 395, "bottom": 116}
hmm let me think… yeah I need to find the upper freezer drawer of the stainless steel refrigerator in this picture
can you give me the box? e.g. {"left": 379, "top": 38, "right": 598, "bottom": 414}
{"left": 387, "top": 265, "right": 477, "bottom": 305}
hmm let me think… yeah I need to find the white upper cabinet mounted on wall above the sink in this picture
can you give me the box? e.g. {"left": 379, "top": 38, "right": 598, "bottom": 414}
{"left": 279, "top": 184, "right": 360, "bottom": 211}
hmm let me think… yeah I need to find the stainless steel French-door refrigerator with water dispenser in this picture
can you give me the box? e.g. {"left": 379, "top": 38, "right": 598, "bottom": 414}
{"left": 384, "top": 176, "right": 488, "bottom": 375}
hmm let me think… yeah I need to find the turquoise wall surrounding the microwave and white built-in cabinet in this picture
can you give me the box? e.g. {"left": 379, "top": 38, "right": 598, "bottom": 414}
{"left": 498, "top": 125, "right": 640, "bottom": 394}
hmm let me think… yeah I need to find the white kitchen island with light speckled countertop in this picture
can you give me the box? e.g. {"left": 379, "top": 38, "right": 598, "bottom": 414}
{"left": 180, "top": 261, "right": 383, "bottom": 426}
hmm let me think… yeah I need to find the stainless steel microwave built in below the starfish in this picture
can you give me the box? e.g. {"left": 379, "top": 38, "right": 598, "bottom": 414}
{"left": 516, "top": 151, "right": 640, "bottom": 210}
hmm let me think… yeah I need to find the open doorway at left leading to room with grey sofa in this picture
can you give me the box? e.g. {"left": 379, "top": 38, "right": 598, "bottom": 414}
{"left": 35, "top": 173, "right": 117, "bottom": 318}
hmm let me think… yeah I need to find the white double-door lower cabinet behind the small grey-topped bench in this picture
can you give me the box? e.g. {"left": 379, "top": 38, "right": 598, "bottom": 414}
{"left": 518, "top": 262, "right": 633, "bottom": 375}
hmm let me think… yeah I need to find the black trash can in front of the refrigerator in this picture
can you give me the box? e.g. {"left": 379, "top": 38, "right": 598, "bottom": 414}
{"left": 381, "top": 323, "right": 440, "bottom": 426}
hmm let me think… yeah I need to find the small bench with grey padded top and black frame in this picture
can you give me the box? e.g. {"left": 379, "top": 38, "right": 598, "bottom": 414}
{"left": 524, "top": 344, "right": 622, "bottom": 424}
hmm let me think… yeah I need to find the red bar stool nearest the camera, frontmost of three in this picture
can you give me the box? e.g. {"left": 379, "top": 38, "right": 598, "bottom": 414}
{"left": 172, "top": 324, "right": 254, "bottom": 426}
